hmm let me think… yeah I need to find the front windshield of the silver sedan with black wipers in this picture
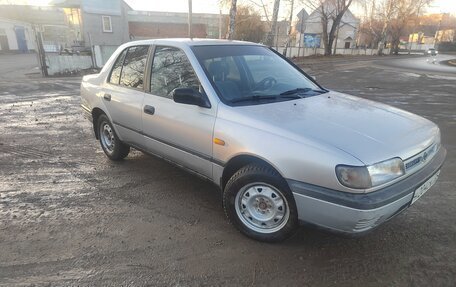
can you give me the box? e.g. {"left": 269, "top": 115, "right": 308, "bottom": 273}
{"left": 192, "top": 45, "right": 326, "bottom": 105}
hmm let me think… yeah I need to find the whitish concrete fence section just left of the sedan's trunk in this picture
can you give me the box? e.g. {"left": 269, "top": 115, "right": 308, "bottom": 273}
{"left": 46, "top": 53, "right": 92, "bottom": 76}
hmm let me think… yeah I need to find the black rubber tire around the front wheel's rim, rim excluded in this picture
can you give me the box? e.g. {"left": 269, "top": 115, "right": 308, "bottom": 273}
{"left": 223, "top": 165, "right": 298, "bottom": 242}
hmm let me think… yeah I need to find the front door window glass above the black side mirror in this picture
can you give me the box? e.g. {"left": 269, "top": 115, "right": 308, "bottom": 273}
{"left": 150, "top": 46, "right": 201, "bottom": 98}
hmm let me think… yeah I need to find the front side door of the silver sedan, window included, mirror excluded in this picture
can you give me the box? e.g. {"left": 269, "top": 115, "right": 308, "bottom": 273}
{"left": 142, "top": 46, "right": 216, "bottom": 177}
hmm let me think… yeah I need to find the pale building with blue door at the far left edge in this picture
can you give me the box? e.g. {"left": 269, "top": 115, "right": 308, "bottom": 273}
{"left": 0, "top": 18, "right": 35, "bottom": 53}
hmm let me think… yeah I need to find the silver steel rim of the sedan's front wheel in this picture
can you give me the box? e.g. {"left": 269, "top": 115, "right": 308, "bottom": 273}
{"left": 235, "top": 183, "right": 290, "bottom": 233}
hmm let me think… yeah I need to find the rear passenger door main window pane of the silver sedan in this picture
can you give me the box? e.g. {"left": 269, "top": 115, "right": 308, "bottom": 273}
{"left": 120, "top": 46, "right": 149, "bottom": 89}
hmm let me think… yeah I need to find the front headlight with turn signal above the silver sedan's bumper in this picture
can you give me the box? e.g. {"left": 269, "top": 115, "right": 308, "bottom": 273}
{"left": 336, "top": 158, "right": 405, "bottom": 189}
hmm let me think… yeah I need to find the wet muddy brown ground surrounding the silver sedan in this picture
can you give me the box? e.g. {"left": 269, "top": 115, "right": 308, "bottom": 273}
{"left": 0, "top": 53, "right": 456, "bottom": 287}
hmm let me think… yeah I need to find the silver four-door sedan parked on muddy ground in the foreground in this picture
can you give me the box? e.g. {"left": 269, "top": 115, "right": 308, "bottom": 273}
{"left": 81, "top": 39, "right": 446, "bottom": 242}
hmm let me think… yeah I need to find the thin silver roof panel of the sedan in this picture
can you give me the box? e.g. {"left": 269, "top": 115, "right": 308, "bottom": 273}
{"left": 121, "top": 38, "right": 263, "bottom": 47}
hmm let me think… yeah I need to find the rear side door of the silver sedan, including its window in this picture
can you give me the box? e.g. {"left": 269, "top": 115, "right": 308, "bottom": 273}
{"left": 101, "top": 45, "right": 149, "bottom": 145}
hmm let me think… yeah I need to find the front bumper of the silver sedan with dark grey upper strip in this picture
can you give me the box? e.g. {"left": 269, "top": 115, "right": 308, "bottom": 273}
{"left": 287, "top": 147, "right": 446, "bottom": 234}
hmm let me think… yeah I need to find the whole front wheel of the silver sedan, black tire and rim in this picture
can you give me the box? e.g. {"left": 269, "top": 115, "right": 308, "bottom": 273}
{"left": 223, "top": 164, "right": 298, "bottom": 242}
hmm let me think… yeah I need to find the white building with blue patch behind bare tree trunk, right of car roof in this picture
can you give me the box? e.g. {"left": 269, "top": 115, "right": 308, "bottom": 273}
{"left": 295, "top": 5, "right": 359, "bottom": 49}
